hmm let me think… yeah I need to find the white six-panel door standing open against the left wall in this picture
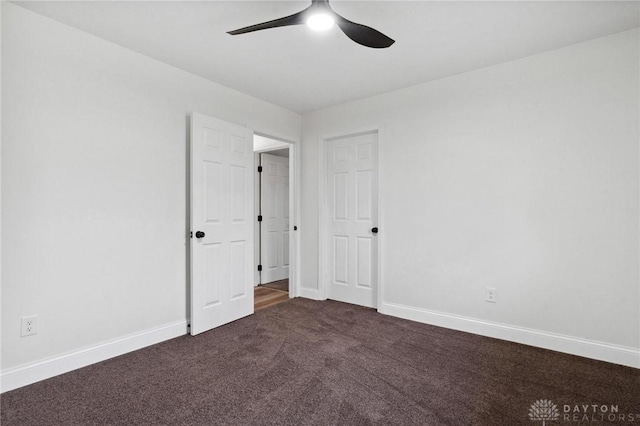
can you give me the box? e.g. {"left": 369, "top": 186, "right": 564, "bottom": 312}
{"left": 191, "top": 113, "right": 254, "bottom": 335}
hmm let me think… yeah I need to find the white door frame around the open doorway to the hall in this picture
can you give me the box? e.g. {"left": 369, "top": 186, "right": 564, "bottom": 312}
{"left": 253, "top": 135, "right": 300, "bottom": 298}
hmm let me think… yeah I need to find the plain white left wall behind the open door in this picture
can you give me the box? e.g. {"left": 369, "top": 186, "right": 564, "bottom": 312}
{"left": 2, "top": 2, "right": 301, "bottom": 372}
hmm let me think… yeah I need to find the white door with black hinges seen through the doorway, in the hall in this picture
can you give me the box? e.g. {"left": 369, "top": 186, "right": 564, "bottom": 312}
{"left": 260, "top": 154, "right": 289, "bottom": 284}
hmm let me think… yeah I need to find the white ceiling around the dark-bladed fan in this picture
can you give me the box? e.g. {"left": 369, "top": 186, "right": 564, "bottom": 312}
{"left": 15, "top": 0, "right": 640, "bottom": 113}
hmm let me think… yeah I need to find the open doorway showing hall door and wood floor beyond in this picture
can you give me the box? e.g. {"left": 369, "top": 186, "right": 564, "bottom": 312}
{"left": 254, "top": 135, "right": 296, "bottom": 310}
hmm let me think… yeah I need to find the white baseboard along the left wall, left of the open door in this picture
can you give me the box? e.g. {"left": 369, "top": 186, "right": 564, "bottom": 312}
{"left": 0, "top": 320, "right": 187, "bottom": 392}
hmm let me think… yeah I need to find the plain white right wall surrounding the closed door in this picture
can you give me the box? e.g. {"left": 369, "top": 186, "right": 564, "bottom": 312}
{"left": 301, "top": 30, "right": 640, "bottom": 366}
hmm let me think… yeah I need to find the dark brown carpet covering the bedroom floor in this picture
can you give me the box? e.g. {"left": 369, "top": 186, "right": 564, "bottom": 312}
{"left": 1, "top": 299, "right": 640, "bottom": 426}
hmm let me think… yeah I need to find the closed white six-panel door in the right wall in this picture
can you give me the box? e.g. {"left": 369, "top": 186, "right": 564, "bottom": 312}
{"left": 325, "top": 132, "right": 378, "bottom": 307}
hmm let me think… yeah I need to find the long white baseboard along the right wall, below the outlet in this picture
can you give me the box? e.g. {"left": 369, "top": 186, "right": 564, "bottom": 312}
{"left": 378, "top": 302, "right": 640, "bottom": 368}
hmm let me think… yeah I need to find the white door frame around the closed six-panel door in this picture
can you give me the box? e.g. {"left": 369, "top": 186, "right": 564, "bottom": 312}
{"left": 318, "top": 126, "right": 385, "bottom": 311}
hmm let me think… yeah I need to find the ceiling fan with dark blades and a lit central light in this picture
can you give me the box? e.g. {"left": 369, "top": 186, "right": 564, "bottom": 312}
{"left": 228, "top": 0, "right": 395, "bottom": 49}
